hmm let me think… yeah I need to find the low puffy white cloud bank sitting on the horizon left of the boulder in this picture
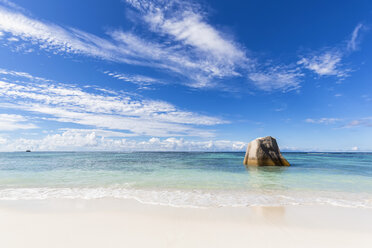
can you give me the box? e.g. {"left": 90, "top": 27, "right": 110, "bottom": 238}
{"left": 0, "top": 130, "right": 246, "bottom": 151}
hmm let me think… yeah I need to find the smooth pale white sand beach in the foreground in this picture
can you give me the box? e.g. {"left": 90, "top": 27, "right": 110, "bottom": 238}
{"left": 0, "top": 199, "right": 372, "bottom": 248}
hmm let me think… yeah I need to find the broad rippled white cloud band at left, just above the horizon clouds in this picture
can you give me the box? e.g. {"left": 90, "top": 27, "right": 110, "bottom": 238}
{"left": 0, "top": 69, "right": 227, "bottom": 137}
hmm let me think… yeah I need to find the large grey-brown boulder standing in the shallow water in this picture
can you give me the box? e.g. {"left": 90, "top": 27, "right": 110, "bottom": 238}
{"left": 244, "top": 136, "right": 290, "bottom": 166}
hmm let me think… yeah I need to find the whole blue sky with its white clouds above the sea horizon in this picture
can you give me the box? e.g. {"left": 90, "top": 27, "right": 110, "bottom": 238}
{"left": 0, "top": 0, "right": 372, "bottom": 151}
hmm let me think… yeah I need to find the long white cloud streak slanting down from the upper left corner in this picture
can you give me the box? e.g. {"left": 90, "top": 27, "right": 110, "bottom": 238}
{"left": 0, "top": 6, "right": 197, "bottom": 78}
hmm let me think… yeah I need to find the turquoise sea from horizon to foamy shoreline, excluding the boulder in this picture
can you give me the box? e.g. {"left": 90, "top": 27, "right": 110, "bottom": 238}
{"left": 0, "top": 152, "right": 372, "bottom": 208}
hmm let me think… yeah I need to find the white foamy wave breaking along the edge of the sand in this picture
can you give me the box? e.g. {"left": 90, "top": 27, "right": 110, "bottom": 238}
{"left": 0, "top": 187, "right": 372, "bottom": 208}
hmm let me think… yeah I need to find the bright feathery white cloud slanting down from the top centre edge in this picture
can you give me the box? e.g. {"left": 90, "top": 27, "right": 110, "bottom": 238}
{"left": 126, "top": 0, "right": 253, "bottom": 88}
